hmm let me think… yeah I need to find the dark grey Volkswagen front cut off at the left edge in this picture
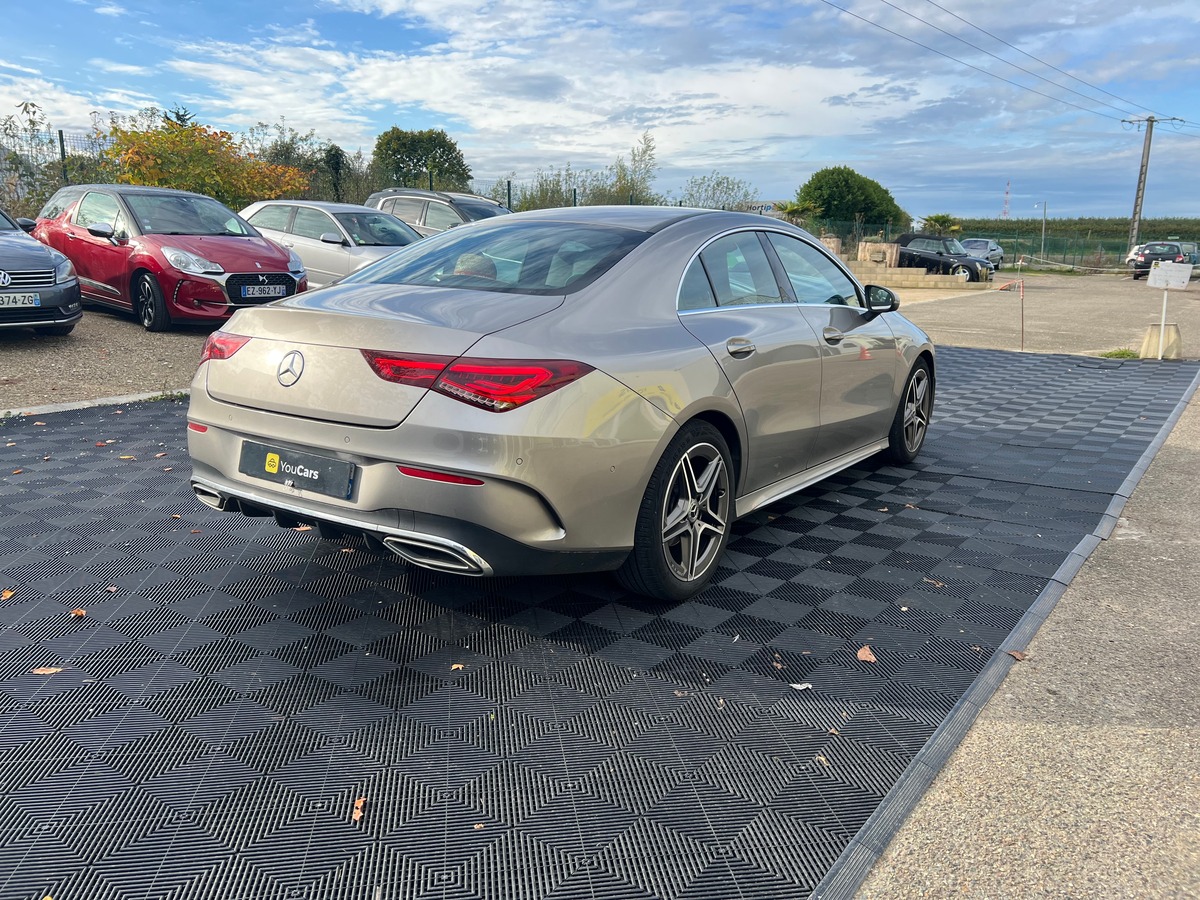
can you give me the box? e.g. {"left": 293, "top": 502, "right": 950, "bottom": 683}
{"left": 0, "top": 210, "right": 83, "bottom": 335}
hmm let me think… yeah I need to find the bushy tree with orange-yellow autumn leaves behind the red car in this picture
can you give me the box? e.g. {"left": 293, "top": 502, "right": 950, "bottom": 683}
{"left": 96, "top": 109, "right": 308, "bottom": 210}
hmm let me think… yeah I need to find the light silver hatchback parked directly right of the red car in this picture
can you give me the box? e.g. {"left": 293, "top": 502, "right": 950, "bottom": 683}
{"left": 239, "top": 200, "right": 421, "bottom": 288}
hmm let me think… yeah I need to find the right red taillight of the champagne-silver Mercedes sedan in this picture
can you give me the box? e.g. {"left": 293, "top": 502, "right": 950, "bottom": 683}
{"left": 362, "top": 350, "right": 592, "bottom": 413}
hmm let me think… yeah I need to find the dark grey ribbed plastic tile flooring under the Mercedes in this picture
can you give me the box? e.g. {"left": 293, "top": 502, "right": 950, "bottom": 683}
{"left": 0, "top": 348, "right": 1198, "bottom": 900}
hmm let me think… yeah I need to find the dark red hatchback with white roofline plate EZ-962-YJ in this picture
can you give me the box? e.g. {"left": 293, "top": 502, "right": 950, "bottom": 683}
{"left": 34, "top": 185, "right": 308, "bottom": 331}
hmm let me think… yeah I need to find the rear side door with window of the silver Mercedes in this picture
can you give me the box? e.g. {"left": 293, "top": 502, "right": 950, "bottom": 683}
{"left": 679, "top": 232, "right": 822, "bottom": 493}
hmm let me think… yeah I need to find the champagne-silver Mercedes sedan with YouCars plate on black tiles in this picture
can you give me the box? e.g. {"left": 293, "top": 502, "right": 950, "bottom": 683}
{"left": 187, "top": 206, "right": 935, "bottom": 600}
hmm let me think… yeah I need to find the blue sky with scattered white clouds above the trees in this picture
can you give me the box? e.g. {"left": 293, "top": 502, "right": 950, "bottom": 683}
{"left": 0, "top": 0, "right": 1200, "bottom": 220}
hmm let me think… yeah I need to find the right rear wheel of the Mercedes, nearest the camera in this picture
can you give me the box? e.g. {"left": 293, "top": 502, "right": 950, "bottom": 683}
{"left": 617, "top": 421, "right": 733, "bottom": 602}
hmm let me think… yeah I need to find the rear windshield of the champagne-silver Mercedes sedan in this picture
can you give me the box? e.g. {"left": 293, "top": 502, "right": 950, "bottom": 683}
{"left": 341, "top": 217, "right": 649, "bottom": 294}
